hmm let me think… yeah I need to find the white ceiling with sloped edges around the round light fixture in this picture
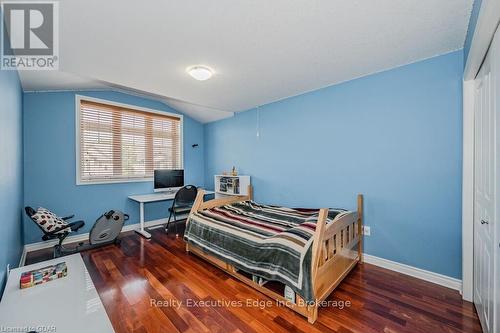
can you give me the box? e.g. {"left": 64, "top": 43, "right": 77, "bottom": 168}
{"left": 20, "top": 0, "right": 473, "bottom": 122}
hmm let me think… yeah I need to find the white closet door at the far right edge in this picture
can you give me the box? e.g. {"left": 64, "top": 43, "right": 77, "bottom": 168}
{"left": 474, "top": 26, "right": 498, "bottom": 333}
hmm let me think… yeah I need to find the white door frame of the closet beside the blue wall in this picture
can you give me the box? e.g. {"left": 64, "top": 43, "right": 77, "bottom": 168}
{"left": 462, "top": 0, "right": 500, "bottom": 302}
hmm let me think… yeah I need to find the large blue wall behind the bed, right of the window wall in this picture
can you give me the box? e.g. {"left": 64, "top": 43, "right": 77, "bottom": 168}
{"left": 205, "top": 50, "right": 463, "bottom": 278}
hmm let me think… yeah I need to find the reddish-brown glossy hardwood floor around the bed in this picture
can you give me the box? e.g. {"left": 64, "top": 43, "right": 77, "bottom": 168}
{"left": 27, "top": 229, "right": 481, "bottom": 333}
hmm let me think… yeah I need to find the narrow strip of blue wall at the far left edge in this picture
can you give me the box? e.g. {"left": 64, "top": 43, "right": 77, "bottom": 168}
{"left": 0, "top": 68, "right": 23, "bottom": 293}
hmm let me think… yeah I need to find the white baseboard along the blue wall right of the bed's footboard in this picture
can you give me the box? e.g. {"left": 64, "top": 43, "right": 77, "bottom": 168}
{"left": 363, "top": 254, "right": 462, "bottom": 292}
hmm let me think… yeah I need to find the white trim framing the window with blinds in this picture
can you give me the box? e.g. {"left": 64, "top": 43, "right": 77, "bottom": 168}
{"left": 75, "top": 94, "right": 184, "bottom": 186}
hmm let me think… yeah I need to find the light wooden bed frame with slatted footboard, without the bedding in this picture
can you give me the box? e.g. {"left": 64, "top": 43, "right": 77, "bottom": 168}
{"left": 186, "top": 186, "right": 363, "bottom": 324}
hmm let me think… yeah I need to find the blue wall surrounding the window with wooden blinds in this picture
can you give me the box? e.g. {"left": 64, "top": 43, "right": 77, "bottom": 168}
{"left": 24, "top": 91, "right": 204, "bottom": 243}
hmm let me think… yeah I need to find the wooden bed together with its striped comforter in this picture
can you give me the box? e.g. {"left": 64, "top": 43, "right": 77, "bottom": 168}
{"left": 184, "top": 187, "right": 363, "bottom": 323}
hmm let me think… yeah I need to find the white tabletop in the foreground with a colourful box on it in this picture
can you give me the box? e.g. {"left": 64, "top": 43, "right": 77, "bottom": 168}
{"left": 0, "top": 254, "right": 114, "bottom": 333}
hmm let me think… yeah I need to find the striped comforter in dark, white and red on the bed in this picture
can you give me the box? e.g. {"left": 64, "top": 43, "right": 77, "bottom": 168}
{"left": 184, "top": 201, "right": 348, "bottom": 301}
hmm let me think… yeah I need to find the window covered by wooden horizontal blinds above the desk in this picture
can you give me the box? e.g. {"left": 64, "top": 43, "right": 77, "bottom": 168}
{"left": 77, "top": 97, "right": 182, "bottom": 184}
